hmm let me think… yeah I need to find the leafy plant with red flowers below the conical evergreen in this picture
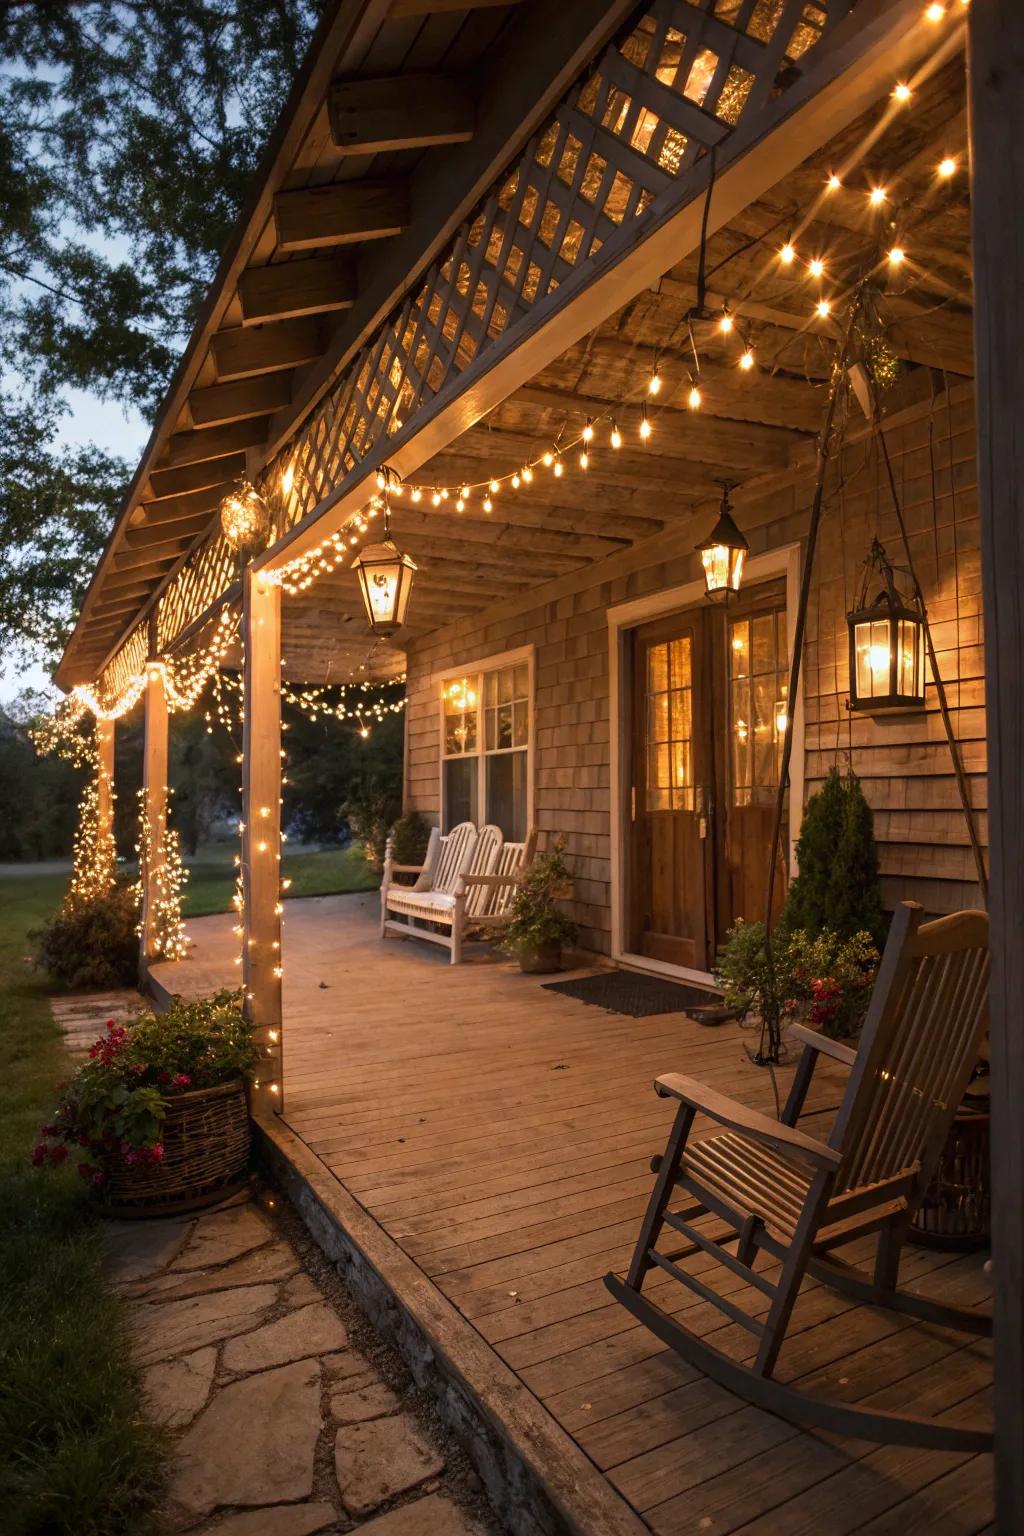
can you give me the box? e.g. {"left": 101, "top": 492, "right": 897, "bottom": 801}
{"left": 715, "top": 922, "right": 878, "bottom": 1035}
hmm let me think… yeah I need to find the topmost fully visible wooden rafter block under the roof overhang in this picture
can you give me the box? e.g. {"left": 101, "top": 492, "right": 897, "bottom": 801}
{"left": 327, "top": 74, "right": 476, "bottom": 155}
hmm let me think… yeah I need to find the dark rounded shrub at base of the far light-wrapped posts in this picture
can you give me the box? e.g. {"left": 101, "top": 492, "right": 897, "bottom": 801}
{"left": 32, "top": 885, "right": 138, "bottom": 991}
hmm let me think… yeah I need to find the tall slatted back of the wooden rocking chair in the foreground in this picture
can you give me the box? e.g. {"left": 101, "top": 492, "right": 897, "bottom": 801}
{"left": 831, "top": 903, "right": 989, "bottom": 1195}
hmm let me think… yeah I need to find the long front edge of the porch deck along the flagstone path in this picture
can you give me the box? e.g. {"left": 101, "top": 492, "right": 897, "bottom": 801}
{"left": 253, "top": 1118, "right": 649, "bottom": 1536}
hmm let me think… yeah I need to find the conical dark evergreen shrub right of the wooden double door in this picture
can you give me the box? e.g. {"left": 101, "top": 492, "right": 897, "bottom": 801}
{"left": 778, "top": 768, "right": 886, "bottom": 946}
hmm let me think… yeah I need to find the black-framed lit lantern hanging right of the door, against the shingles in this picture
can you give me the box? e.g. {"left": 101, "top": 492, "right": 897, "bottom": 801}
{"left": 846, "top": 539, "right": 924, "bottom": 714}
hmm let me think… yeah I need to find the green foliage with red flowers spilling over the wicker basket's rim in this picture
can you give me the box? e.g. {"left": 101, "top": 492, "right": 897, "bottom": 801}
{"left": 32, "top": 992, "right": 258, "bottom": 1186}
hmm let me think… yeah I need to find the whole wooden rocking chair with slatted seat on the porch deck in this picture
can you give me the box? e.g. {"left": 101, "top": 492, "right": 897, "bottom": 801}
{"left": 605, "top": 902, "right": 992, "bottom": 1452}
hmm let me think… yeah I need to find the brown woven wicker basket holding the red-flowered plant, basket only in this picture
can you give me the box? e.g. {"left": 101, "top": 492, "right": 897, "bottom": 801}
{"left": 101, "top": 1077, "right": 250, "bottom": 1217}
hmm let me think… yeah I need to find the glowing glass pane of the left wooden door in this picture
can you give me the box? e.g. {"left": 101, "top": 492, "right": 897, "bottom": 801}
{"left": 643, "top": 634, "right": 694, "bottom": 811}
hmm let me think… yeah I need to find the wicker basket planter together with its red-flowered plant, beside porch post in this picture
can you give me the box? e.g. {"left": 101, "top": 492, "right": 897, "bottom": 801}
{"left": 32, "top": 992, "right": 258, "bottom": 1217}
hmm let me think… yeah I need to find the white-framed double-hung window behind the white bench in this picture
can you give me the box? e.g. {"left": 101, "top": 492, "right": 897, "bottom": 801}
{"left": 441, "top": 653, "right": 531, "bottom": 842}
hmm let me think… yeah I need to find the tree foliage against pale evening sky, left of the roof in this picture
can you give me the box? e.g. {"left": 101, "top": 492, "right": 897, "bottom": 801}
{"left": 0, "top": 0, "right": 321, "bottom": 657}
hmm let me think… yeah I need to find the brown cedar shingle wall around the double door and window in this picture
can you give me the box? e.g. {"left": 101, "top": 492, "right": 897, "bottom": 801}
{"left": 405, "top": 384, "right": 987, "bottom": 954}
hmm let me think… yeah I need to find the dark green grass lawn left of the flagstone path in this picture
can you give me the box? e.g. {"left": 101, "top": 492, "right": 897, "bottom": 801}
{"left": 0, "top": 874, "right": 161, "bottom": 1536}
